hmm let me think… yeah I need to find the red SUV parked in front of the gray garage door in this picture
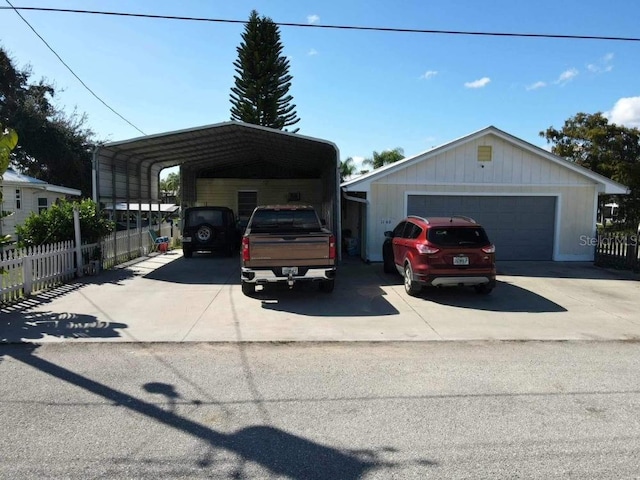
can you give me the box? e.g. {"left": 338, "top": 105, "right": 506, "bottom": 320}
{"left": 382, "top": 215, "right": 496, "bottom": 295}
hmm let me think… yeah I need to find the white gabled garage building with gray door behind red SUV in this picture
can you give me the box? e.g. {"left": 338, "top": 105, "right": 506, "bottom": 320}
{"left": 341, "top": 126, "right": 628, "bottom": 261}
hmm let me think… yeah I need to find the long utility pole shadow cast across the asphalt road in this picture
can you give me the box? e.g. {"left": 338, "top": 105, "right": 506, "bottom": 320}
{"left": 0, "top": 345, "right": 420, "bottom": 480}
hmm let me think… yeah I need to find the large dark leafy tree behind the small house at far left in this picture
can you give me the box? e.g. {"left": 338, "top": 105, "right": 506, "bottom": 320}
{"left": 0, "top": 47, "right": 94, "bottom": 197}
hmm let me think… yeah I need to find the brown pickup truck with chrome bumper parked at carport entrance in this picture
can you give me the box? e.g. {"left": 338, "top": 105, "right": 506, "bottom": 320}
{"left": 241, "top": 205, "right": 336, "bottom": 295}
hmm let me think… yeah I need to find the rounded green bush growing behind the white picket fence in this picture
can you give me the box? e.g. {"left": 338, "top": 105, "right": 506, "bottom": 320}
{"left": 16, "top": 199, "right": 115, "bottom": 247}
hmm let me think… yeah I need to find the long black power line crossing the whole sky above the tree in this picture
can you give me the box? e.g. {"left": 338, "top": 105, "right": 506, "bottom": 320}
{"left": 0, "top": 5, "right": 640, "bottom": 42}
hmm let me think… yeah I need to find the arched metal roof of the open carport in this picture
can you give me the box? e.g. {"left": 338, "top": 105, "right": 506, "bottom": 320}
{"left": 96, "top": 121, "right": 338, "bottom": 180}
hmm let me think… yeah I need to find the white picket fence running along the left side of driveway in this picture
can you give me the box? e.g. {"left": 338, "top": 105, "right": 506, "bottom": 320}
{"left": 0, "top": 224, "right": 171, "bottom": 303}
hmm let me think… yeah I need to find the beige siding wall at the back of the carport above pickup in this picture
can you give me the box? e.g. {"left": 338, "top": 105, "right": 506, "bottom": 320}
{"left": 196, "top": 178, "right": 322, "bottom": 215}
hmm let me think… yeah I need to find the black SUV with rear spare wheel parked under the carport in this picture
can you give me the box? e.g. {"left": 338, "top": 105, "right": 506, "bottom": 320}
{"left": 182, "top": 207, "right": 240, "bottom": 258}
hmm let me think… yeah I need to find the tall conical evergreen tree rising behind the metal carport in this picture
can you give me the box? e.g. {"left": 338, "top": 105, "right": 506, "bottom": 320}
{"left": 230, "top": 10, "right": 300, "bottom": 133}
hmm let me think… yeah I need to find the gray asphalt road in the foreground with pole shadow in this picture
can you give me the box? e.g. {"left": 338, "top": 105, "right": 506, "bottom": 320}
{"left": 0, "top": 342, "right": 640, "bottom": 480}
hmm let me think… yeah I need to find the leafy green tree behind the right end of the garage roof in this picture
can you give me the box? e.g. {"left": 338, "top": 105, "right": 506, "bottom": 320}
{"left": 540, "top": 113, "right": 640, "bottom": 226}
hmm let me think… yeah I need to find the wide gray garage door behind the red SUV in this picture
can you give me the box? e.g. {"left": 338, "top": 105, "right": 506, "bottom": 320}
{"left": 407, "top": 195, "right": 556, "bottom": 260}
